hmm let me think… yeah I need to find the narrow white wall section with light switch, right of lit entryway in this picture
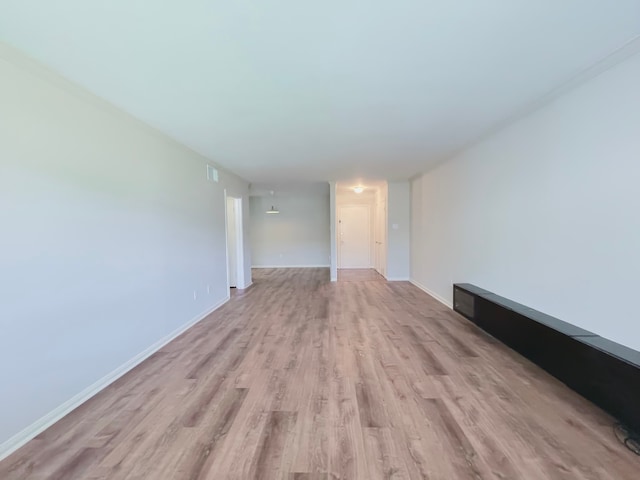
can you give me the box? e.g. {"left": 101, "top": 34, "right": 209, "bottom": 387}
{"left": 387, "top": 181, "right": 411, "bottom": 280}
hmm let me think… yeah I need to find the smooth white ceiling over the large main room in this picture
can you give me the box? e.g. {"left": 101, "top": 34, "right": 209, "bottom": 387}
{"left": 0, "top": 0, "right": 640, "bottom": 182}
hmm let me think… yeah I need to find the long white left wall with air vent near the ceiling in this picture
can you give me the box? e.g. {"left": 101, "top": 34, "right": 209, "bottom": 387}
{"left": 0, "top": 45, "right": 251, "bottom": 456}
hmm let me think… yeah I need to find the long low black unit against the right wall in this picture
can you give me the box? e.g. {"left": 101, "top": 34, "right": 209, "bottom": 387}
{"left": 453, "top": 283, "right": 640, "bottom": 432}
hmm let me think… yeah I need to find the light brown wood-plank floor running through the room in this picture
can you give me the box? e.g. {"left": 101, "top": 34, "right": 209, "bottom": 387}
{"left": 0, "top": 269, "right": 640, "bottom": 480}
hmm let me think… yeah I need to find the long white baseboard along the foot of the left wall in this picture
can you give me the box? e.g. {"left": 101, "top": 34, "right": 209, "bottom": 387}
{"left": 0, "top": 295, "right": 230, "bottom": 460}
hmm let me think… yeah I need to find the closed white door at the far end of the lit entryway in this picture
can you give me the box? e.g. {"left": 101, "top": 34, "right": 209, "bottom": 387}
{"left": 338, "top": 205, "right": 371, "bottom": 268}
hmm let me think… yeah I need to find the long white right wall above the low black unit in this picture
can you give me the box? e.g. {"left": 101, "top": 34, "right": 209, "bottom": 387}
{"left": 411, "top": 50, "right": 640, "bottom": 350}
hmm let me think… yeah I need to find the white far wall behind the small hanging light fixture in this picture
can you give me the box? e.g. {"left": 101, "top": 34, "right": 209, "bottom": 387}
{"left": 250, "top": 194, "right": 331, "bottom": 267}
